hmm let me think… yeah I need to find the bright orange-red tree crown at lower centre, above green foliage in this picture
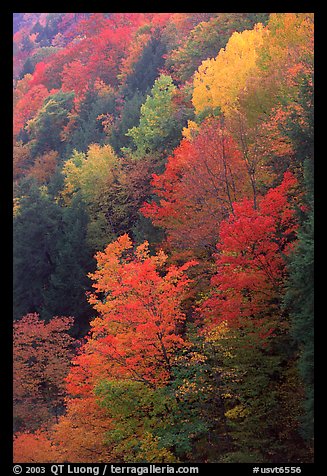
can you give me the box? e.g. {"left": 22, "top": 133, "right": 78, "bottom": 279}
{"left": 79, "top": 235, "right": 195, "bottom": 386}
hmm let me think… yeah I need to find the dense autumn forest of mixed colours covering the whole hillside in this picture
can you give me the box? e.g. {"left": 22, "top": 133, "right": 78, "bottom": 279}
{"left": 13, "top": 13, "right": 314, "bottom": 463}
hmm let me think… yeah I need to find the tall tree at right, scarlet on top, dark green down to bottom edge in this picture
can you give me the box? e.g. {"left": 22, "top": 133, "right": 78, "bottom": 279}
{"left": 200, "top": 172, "right": 310, "bottom": 463}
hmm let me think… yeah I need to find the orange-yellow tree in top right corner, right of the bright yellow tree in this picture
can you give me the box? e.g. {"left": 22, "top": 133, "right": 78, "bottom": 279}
{"left": 240, "top": 13, "right": 314, "bottom": 124}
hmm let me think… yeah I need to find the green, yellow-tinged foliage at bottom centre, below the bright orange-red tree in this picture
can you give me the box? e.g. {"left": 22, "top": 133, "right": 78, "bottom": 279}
{"left": 95, "top": 336, "right": 213, "bottom": 463}
